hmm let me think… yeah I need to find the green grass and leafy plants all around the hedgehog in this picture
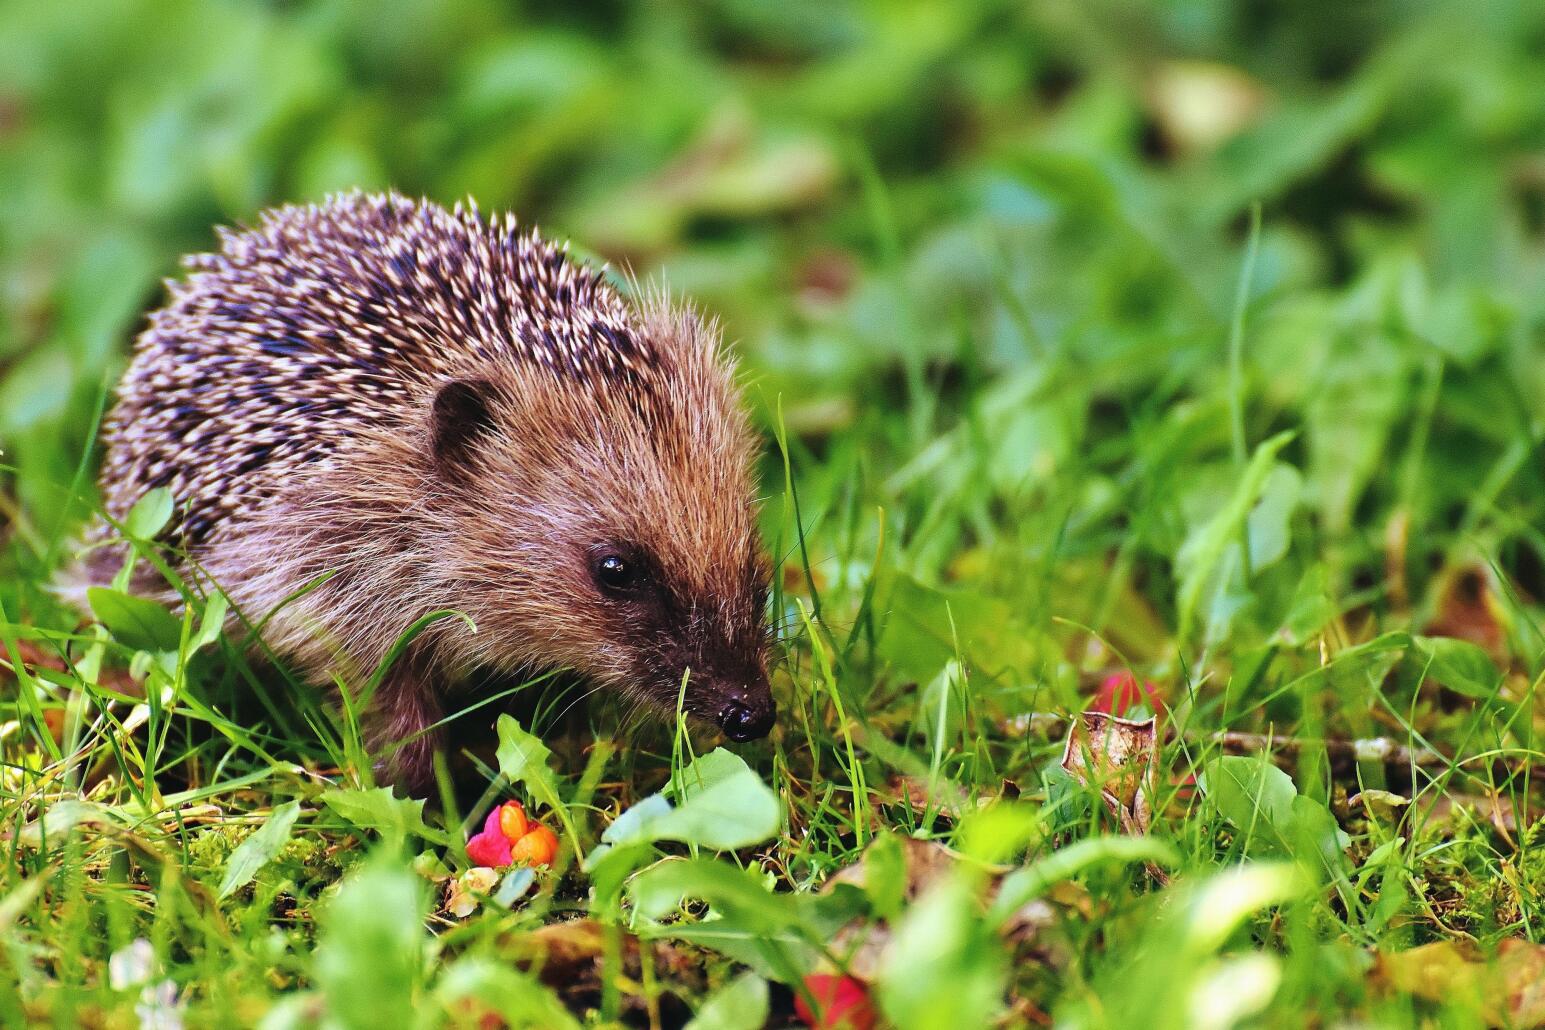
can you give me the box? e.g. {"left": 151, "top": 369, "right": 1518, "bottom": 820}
{"left": 0, "top": 0, "right": 1545, "bottom": 1027}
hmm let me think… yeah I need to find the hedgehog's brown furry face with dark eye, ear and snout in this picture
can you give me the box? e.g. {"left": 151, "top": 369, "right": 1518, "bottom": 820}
{"left": 434, "top": 315, "right": 776, "bottom": 741}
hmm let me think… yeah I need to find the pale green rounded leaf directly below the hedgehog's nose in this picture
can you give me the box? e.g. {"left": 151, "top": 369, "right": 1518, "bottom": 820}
{"left": 601, "top": 747, "right": 783, "bottom": 851}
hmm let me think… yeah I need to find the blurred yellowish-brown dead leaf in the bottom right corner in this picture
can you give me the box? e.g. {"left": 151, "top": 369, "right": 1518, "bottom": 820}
{"left": 1374, "top": 939, "right": 1545, "bottom": 1027}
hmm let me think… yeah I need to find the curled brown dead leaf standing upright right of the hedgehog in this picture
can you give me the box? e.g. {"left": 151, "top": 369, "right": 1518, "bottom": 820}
{"left": 1061, "top": 712, "right": 1157, "bottom": 835}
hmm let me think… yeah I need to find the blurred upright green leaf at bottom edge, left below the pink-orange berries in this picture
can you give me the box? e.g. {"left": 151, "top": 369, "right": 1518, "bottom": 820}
{"left": 314, "top": 857, "right": 428, "bottom": 1030}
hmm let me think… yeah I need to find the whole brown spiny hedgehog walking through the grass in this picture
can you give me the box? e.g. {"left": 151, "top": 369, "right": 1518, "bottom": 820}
{"left": 77, "top": 193, "right": 776, "bottom": 791}
